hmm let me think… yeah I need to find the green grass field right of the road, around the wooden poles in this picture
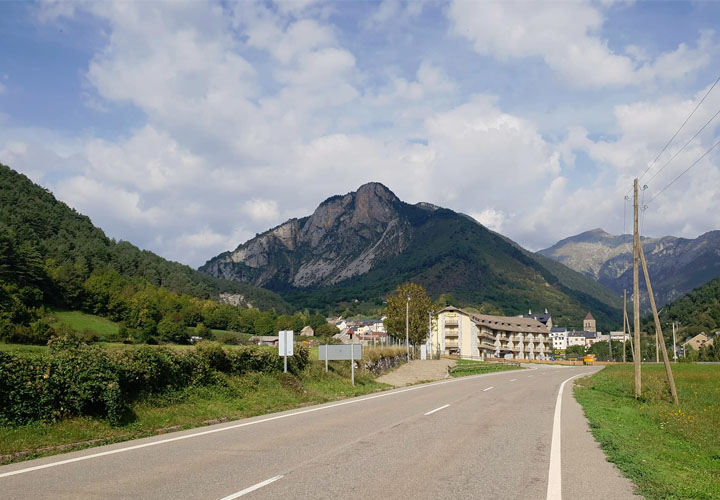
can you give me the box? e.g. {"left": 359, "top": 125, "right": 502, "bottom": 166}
{"left": 575, "top": 364, "right": 720, "bottom": 500}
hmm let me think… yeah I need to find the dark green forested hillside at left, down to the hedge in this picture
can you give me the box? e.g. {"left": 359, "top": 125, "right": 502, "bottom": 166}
{"left": 0, "top": 165, "right": 289, "bottom": 344}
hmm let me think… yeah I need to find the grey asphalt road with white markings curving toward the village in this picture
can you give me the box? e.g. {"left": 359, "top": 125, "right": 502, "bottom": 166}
{"left": 0, "top": 366, "right": 638, "bottom": 500}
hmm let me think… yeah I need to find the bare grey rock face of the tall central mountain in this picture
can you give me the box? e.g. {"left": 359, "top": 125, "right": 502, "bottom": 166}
{"left": 200, "top": 183, "right": 412, "bottom": 289}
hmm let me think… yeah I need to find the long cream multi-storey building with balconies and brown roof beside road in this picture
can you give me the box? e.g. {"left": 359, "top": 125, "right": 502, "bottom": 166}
{"left": 429, "top": 307, "right": 552, "bottom": 359}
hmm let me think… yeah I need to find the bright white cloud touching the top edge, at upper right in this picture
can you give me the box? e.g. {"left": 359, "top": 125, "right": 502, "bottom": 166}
{"left": 448, "top": 0, "right": 717, "bottom": 87}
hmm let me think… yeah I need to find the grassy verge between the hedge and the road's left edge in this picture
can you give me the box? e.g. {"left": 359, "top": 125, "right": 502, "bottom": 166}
{"left": 0, "top": 362, "right": 388, "bottom": 463}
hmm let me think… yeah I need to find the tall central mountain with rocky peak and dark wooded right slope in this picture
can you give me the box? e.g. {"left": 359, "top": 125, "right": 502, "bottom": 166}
{"left": 200, "top": 183, "right": 621, "bottom": 325}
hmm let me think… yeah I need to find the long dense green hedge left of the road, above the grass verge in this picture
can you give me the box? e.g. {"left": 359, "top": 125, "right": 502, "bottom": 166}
{"left": 0, "top": 339, "right": 310, "bottom": 425}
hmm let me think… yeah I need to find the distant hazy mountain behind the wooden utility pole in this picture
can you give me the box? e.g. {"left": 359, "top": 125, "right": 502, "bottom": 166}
{"left": 538, "top": 229, "right": 720, "bottom": 307}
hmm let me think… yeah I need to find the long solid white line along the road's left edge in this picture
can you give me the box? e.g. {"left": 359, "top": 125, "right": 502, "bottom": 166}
{"left": 0, "top": 372, "right": 507, "bottom": 479}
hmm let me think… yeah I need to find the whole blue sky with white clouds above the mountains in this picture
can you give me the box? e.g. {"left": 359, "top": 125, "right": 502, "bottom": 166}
{"left": 0, "top": 0, "right": 720, "bottom": 266}
